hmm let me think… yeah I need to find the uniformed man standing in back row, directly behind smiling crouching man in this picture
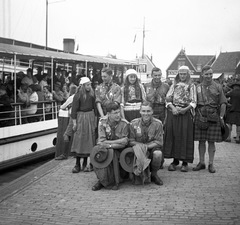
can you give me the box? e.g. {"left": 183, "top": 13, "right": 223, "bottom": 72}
{"left": 145, "top": 67, "right": 169, "bottom": 123}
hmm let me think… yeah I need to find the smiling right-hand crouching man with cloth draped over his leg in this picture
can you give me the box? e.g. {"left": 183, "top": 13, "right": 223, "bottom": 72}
{"left": 125, "top": 102, "right": 163, "bottom": 185}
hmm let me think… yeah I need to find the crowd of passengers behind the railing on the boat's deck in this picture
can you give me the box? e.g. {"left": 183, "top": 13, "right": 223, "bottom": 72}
{"left": 0, "top": 67, "right": 106, "bottom": 127}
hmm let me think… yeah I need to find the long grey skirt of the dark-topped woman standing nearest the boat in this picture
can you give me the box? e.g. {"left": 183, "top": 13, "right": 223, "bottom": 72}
{"left": 71, "top": 111, "right": 96, "bottom": 157}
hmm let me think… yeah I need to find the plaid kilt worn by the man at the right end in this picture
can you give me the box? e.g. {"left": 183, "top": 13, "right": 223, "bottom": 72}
{"left": 194, "top": 111, "right": 222, "bottom": 142}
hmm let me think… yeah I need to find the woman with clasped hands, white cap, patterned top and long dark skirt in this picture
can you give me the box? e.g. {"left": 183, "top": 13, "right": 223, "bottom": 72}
{"left": 163, "top": 66, "right": 197, "bottom": 172}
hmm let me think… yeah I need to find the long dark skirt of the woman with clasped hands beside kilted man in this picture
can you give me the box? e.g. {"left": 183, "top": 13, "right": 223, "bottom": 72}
{"left": 163, "top": 110, "right": 194, "bottom": 163}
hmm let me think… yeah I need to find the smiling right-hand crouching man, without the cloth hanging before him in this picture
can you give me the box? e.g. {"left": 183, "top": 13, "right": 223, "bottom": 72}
{"left": 129, "top": 102, "right": 163, "bottom": 185}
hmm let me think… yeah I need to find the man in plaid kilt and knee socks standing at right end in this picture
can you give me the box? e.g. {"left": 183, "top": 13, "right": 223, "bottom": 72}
{"left": 193, "top": 66, "right": 227, "bottom": 173}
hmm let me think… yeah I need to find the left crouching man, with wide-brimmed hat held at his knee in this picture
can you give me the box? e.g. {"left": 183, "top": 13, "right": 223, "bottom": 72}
{"left": 90, "top": 102, "right": 129, "bottom": 191}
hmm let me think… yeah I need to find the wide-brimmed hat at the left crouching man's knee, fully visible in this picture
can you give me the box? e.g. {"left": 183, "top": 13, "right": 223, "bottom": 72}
{"left": 90, "top": 146, "right": 113, "bottom": 169}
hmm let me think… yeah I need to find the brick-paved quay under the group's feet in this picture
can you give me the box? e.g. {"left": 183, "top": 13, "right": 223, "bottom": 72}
{"left": 0, "top": 142, "right": 240, "bottom": 225}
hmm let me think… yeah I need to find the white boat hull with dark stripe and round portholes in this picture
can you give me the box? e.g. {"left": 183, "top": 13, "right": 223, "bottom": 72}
{"left": 0, "top": 119, "right": 57, "bottom": 170}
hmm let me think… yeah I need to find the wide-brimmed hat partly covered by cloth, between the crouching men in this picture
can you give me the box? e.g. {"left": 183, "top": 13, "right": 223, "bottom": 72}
{"left": 120, "top": 148, "right": 134, "bottom": 173}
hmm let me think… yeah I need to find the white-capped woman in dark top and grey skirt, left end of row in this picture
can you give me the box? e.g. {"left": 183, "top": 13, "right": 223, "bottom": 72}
{"left": 71, "top": 77, "right": 96, "bottom": 173}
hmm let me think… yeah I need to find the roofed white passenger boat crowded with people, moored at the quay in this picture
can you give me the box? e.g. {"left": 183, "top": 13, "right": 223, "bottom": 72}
{"left": 0, "top": 38, "right": 137, "bottom": 170}
